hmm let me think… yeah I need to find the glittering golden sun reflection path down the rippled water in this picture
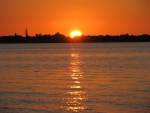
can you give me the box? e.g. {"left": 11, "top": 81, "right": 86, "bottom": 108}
{"left": 61, "top": 46, "right": 88, "bottom": 112}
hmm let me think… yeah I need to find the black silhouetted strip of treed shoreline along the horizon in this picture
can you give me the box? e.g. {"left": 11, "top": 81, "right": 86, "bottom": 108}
{"left": 0, "top": 33, "right": 150, "bottom": 43}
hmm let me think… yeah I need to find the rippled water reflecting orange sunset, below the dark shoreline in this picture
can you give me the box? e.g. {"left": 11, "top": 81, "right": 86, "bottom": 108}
{"left": 0, "top": 43, "right": 150, "bottom": 113}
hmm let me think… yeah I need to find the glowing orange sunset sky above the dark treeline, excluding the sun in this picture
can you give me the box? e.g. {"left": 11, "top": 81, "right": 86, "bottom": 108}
{"left": 0, "top": 0, "right": 150, "bottom": 36}
